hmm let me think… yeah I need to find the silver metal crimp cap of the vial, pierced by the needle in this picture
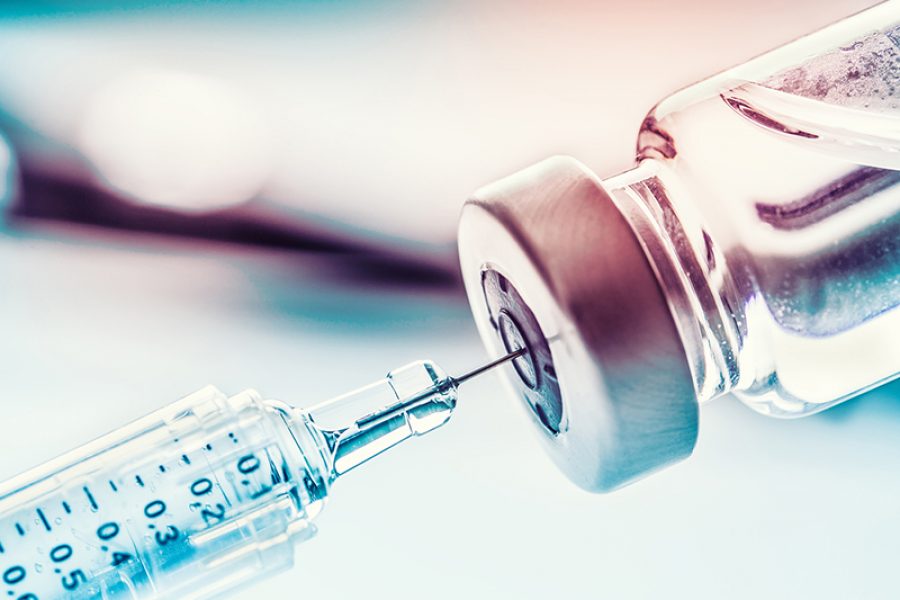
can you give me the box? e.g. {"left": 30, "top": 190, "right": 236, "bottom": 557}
{"left": 459, "top": 158, "right": 698, "bottom": 492}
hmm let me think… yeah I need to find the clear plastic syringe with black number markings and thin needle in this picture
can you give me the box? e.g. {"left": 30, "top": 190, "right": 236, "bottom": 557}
{"left": 0, "top": 350, "right": 525, "bottom": 600}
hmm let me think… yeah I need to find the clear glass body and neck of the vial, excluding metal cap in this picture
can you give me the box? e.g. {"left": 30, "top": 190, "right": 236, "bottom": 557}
{"left": 607, "top": 1, "right": 900, "bottom": 416}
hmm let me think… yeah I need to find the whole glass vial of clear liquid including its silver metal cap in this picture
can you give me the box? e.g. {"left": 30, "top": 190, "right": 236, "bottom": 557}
{"left": 460, "top": 1, "right": 900, "bottom": 490}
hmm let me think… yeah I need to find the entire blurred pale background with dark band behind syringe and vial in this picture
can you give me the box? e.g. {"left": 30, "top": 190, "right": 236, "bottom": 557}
{"left": 0, "top": 0, "right": 900, "bottom": 599}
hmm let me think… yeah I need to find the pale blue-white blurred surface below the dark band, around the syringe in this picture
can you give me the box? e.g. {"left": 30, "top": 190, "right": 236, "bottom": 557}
{"left": 0, "top": 230, "right": 900, "bottom": 600}
